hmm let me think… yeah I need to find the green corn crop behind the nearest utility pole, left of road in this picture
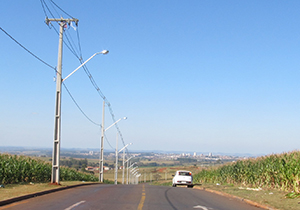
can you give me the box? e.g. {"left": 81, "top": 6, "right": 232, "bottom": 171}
{"left": 0, "top": 154, "right": 98, "bottom": 184}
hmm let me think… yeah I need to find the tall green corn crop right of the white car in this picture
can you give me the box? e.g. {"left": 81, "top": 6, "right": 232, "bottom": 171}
{"left": 194, "top": 151, "right": 300, "bottom": 193}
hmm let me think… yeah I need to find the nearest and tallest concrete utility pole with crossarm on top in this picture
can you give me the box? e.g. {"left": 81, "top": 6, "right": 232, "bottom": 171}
{"left": 45, "top": 17, "right": 78, "bottom": 184}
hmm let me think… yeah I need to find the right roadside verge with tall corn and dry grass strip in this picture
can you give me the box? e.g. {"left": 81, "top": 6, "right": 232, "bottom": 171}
{"left": 194, "top": 151, "right": 300, "bottom": 209}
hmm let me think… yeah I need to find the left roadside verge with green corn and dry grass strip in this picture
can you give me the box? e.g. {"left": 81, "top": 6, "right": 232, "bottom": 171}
{"left": 0, "top": 154, "right": 116, "bottom": 201}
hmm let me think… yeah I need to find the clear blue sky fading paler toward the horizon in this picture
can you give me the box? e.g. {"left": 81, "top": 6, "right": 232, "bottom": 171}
{"left": 0, "top": 0, "right": 300, "bottom": 154}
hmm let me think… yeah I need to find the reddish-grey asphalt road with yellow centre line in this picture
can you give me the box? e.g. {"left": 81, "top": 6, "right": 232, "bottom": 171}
{"left": 0, "top": 184, "right": 259, "bottom": 210}
